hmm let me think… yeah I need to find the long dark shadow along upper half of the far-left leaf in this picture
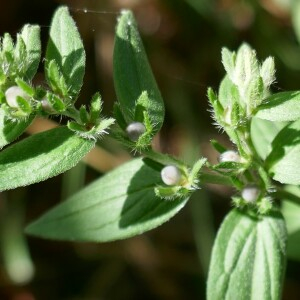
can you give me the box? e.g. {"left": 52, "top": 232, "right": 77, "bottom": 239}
{"left": 0, "top": 127, "right": 74, "bottom": 165}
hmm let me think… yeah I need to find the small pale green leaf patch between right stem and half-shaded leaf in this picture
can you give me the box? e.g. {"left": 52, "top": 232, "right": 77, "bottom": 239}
{"left": 251, "top": 117, "right": 287, "bottom": 159}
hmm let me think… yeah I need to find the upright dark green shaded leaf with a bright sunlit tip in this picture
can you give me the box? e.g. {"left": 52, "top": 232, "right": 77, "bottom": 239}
{"left": 113, "top": 10, "right": 164, "bottom": 133}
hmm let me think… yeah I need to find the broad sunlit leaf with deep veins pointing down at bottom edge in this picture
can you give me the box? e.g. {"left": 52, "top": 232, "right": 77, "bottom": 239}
{"left": 207, "top": 209, "right": 287, "bottom": 300}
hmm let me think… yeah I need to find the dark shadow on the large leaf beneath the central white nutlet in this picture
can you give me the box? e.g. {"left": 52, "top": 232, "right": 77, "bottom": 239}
{"left": 119, "top": 160, "right": 186, "bottom": 228}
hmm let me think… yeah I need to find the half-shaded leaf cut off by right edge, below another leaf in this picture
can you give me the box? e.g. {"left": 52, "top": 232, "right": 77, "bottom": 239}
{"left": 266, "top": 120, "right": 300, "bottom": 184}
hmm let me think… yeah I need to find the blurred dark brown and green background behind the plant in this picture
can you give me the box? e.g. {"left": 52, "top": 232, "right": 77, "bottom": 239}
{"left": 0, "top": 0, "right": 300, "bottom": 300}
